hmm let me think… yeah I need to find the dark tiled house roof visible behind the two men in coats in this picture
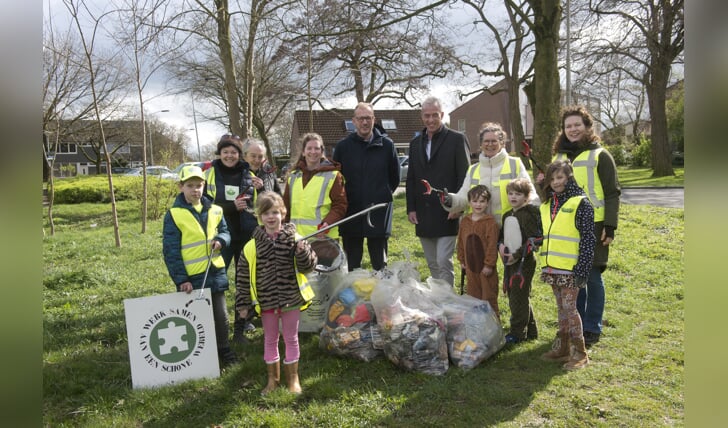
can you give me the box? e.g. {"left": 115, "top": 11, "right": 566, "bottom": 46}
{"left": 291, "top": 109, "right": 424, "bottom": 155}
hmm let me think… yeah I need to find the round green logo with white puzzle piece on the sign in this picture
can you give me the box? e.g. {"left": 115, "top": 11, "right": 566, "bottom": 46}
{"left": 149, "top": 317, "right": 197, "bottom": 363}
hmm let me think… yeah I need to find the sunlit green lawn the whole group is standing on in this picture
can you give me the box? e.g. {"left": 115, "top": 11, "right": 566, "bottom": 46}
{"left": 43, "top": 196, "right": 685, "bottom": 427}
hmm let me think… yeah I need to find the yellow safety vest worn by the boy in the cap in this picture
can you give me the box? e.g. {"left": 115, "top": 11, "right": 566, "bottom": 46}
{"left": 169, "top": 204, "right": 225, "bottom": 276}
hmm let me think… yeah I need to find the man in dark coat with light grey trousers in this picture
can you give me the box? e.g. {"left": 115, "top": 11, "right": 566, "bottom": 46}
{"left": 407, "top": 97, "right": 470, "bottom": 285}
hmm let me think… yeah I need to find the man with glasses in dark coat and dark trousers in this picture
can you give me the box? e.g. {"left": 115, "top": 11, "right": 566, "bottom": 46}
{"left": 333, "top": 103, "right": 399, "bottom": 271}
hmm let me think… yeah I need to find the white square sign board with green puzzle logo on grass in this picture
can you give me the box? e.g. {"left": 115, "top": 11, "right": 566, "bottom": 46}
{"left": 124, "top": 288, "right": 220, "bottom": 389}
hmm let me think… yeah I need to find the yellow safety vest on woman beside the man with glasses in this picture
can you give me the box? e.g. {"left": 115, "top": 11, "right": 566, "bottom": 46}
{"left": 288, "top": 170, "right": 339, "bottom": 239}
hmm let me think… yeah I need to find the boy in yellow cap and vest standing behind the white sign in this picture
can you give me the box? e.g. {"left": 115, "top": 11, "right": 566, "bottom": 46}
{"left": 162, "top": 165, "right": 238, "bottom": 366}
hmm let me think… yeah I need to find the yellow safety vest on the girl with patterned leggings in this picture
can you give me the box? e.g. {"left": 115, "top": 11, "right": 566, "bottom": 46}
{"left": 539, "top": 196, "right": 586, "bottom": 271}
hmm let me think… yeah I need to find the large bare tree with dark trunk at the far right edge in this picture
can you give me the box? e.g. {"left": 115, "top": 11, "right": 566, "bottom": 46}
{"left": 589, "top": 0, "right": 685, "bottom": 177}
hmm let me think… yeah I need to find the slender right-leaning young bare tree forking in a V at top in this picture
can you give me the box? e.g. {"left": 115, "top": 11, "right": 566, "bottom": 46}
{"left": 63, "top": 0, "right": 121, "bottom": 247}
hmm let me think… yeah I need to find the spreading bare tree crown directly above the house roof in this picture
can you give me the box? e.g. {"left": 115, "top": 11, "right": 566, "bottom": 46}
{"left": 285, "top": 0, "right": 452, "bottom": 105}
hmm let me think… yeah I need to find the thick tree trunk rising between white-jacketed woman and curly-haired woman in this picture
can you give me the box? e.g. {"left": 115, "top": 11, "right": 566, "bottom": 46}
{"left": 529, "top": 0, "right": 561, "bottom": 171}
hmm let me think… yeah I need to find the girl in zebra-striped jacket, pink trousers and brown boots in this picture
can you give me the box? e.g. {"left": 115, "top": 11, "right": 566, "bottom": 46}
{"left": 235, "top": 192, "right": 317, "bottom": 395}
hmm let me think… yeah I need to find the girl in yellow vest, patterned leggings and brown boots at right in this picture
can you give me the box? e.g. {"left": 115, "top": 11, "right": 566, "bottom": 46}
{"left": 539, "top": 161, "right": 596, "bottom": 370}
